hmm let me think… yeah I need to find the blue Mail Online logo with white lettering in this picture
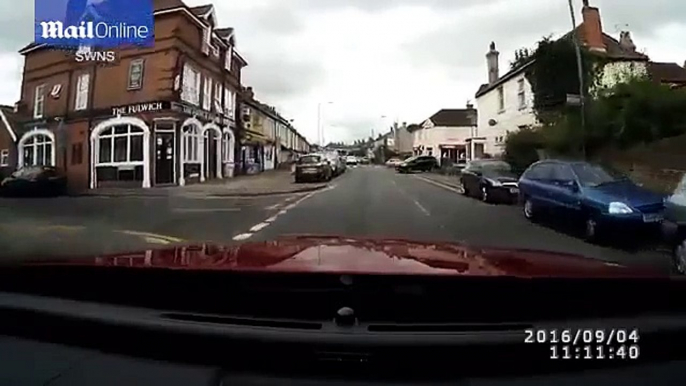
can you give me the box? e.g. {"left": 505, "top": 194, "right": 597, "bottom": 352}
{"left": 35, "top": 0, "right": 155, "bottom": 49}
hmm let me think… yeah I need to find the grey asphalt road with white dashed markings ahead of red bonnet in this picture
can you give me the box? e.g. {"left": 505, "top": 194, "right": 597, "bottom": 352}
{"left": 0, "top": 167, "right": 670, "bottom": 270}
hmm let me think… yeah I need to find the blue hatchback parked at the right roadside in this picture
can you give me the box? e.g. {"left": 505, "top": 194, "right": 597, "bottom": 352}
{"left": 519, "top": 160, "right": 665, "bottom": 241}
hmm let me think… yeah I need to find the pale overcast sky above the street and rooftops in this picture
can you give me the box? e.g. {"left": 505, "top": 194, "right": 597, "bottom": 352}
{"left": 0, "top": 0, "right": 686, "bottom": 143}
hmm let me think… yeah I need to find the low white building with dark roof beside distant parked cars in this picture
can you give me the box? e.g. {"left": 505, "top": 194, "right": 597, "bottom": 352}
{"left": 412, "top": 105, "right": 484, "bottom": 162}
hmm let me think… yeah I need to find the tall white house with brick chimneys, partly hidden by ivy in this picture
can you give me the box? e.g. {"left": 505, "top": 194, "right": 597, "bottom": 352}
{"left": 476, "top": 0, "right": 649, "bottom": 156}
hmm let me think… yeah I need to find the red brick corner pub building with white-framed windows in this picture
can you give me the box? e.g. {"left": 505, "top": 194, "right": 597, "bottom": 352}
{"left": 0, "top": 0, "right": 247, "bottom": 191}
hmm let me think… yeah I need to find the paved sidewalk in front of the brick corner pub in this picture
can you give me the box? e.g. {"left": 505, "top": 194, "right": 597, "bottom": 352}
{"left": 79, "top": 170, "right": 327, "bottom": 197}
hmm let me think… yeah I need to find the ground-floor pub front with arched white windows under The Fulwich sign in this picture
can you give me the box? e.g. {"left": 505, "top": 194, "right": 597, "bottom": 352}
{"left": 86, "top": 102, "right": 235, "bottom": 189}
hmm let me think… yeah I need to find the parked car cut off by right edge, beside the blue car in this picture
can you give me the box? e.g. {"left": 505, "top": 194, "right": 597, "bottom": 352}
{"left": 665, "top": 174, "right": 686, "bottom": 275}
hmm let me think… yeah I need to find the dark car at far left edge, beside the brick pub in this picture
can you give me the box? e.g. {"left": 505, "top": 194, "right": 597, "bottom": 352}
{"left": 0, "top": 166, "right": 67, "bottom": 197}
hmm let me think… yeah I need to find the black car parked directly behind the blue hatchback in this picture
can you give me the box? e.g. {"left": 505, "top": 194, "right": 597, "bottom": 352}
{"left": 460, "top": 160, "right": 519, "bottom": 203}
